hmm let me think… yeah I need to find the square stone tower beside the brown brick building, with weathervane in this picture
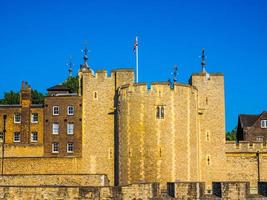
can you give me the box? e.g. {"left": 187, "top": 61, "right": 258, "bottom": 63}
{"left": 78, "top": 47, "right": 134, "bottom": 184}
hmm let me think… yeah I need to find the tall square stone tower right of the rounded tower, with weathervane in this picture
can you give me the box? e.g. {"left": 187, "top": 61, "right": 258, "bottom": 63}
{"left": 190, "top": 51, "right": 225, "bottom": 190}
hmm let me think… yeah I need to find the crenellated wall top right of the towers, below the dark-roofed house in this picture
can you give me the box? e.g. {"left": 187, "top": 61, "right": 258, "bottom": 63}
{"left": 225, "top": 141, "right": 267, "bottom": 154}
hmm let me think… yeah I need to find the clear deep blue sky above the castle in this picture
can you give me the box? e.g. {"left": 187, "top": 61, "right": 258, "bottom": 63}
{"left": 0, "top": 0, "right": 267, "bottom": 130}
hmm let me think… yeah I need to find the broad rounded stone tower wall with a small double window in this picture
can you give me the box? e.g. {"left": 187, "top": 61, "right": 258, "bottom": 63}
{"left": 119, "top": 83, "right": 198, "bottom": 184}
